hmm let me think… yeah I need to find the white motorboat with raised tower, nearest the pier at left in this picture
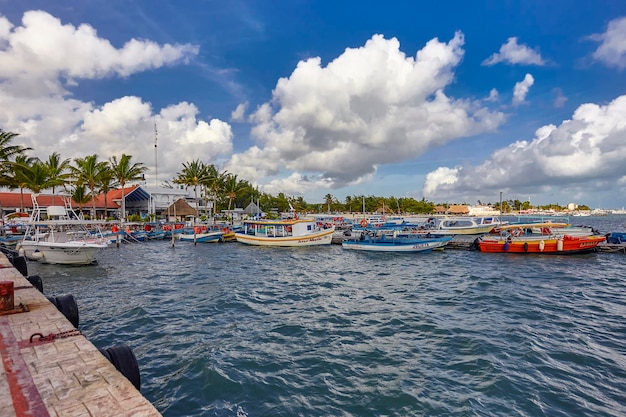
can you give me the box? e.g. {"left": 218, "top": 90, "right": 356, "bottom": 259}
{"left": 16, "top": 195, "right": 109, "bottom": 265}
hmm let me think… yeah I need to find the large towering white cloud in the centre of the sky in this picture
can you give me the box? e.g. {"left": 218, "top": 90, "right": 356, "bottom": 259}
{"left": 226, "top": 32, "right": 504, "bottom": 192}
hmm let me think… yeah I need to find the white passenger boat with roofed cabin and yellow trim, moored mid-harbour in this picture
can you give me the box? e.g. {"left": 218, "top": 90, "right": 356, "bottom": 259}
{"left": 235, "top": 218, "right": 335, "bottom": 246}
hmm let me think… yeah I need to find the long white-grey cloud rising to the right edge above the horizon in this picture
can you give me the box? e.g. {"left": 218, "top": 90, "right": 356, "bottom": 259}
{"left": 423, "top": 95, "right": 626, "bottom": 198}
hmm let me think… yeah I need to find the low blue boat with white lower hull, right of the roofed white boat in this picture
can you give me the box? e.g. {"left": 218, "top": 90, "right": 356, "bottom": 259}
{"left": 341, "top": 231, "right": 452, "bottom": 252}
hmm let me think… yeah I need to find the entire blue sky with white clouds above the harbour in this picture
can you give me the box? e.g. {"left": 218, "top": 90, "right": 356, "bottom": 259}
{"left": 0, "top": 0, "right": 626, "bottom": 208}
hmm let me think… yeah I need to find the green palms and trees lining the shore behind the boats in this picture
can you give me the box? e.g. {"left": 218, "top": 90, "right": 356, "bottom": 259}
{"left": 0, "top": 130, "right": 588, "bottom": 217}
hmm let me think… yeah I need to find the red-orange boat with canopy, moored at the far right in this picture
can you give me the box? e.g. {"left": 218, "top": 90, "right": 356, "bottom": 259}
{"left": 473, "top": 223, "right": 606, "bottom": 254}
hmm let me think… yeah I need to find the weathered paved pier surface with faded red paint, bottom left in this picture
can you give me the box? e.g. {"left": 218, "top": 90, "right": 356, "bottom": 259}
{"left": 0, "top": 254, "right": 161, "bottom": 417}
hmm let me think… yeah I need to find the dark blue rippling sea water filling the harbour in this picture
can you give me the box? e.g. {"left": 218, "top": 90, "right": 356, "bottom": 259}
{"left": 29, "top": 216, "right": 626, "bottom": 417}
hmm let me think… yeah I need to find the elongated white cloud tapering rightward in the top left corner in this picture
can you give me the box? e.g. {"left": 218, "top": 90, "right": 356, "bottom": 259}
{"left": 0, "top": 11, "right": 198, "bottom": 81}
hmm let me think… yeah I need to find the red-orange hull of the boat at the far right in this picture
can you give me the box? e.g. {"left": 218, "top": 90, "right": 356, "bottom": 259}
{"left": 478, "top": 235, "right": 605, "bottom": 254}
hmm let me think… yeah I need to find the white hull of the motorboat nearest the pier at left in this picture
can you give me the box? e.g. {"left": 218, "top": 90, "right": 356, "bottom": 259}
{"left": 17, "top": 241, "right": 107, "bottom": 265}
